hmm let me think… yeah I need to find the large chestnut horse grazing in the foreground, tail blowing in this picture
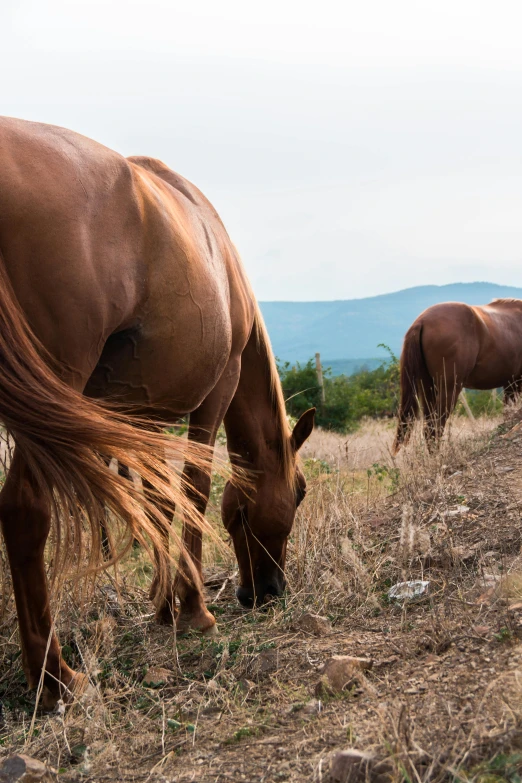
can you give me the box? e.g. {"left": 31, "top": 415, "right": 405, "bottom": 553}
{"left": 0, "top": 118, "right": 314, "bottom": 706}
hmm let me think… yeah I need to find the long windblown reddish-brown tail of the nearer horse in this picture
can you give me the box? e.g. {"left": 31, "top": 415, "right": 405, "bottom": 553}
{"left": 0, "top": 253, "right": 218, "bottom": 591}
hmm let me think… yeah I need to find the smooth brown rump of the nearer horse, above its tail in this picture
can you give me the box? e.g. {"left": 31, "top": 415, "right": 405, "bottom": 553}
{"left": 0, "top": 118, "right": 145, "bottom": 367}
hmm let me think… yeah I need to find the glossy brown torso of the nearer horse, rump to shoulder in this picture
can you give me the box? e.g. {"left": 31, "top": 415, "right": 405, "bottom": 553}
{"left": 0, "top": 118, "right": 254, "bottom": 407}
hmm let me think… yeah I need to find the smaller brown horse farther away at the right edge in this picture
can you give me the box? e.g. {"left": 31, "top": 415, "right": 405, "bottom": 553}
{"left": 393, "top": 299, "right": 522, "bottom": 454}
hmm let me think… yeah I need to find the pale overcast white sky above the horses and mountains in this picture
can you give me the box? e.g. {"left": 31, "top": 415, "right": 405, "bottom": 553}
{"left": 0, "top": 0, "right": 522, "bottom": 301}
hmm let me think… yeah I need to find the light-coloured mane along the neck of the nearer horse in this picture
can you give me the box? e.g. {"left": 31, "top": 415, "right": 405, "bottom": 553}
{"left": 254, "top": 303, "right": 296, "bottom": 485}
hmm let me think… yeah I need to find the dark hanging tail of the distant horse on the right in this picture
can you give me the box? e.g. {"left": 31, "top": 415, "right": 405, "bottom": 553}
{"left": 392, "top": 322, "right": 433, "bottom": 455}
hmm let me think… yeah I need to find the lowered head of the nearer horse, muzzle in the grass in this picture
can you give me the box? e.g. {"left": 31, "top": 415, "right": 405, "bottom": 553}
{"left": 222, "top": 409, "right": 315, "bottom": 608}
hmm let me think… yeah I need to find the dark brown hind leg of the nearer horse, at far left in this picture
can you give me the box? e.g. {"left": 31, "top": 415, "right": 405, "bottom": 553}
{"left": 0, "top": 451, "right": 87, "bottom": 709}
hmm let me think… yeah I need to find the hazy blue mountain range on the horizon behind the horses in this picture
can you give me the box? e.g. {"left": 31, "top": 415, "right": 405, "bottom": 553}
{"left": 260, "top": 283, "right": 522, "bottom": 374}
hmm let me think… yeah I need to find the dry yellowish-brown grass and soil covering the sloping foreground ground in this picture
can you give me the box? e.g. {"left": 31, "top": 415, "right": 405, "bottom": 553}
{"left": 0, "top": 413, "right": 522, "bottom": 783}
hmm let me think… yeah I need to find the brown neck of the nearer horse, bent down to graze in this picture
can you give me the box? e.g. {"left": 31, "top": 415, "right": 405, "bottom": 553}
{"left": 225, "top": 320, "right": 291, "bottom": 475}
